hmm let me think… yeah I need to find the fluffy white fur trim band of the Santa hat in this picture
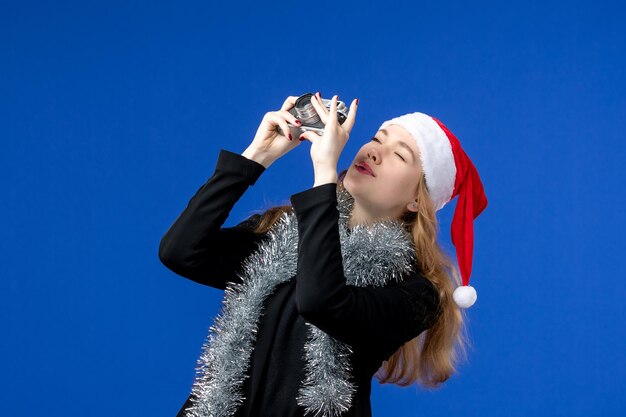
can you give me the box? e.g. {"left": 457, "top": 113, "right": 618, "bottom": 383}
{"left": 379, "top": 112, "right": 456, "bottom": 210}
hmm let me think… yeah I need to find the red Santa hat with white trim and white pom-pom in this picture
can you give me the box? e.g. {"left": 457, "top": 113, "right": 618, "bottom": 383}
{"left": 379, "top": 112, "right": 487, "bottom": 308}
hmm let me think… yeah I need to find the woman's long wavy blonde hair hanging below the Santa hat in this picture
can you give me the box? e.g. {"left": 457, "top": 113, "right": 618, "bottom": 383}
{"left": 249, "top": 170, "right": 470, "bottom": 389}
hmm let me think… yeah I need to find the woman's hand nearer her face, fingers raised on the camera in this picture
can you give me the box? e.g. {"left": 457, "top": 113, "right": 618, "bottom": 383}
{"left": 300, "top": 93, "right": 359, "bottom": 172}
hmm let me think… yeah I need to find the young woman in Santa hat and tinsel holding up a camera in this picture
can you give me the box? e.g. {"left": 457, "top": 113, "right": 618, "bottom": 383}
{"left": 159, "top": 93, "right": 487, "bottom": 417}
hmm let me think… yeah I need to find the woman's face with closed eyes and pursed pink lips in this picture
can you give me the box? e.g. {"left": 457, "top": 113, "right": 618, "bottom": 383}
{"left": 343, "top": 124, "right": 422, "bottom": 223}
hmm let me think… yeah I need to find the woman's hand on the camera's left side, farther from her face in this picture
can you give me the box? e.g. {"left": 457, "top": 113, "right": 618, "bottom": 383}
{"left": 242, "top": 96, "right": 302, "bottom": 168}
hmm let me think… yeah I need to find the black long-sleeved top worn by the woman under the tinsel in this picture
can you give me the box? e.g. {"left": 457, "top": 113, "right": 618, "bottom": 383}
{"left": 159, "top": 149, "right": 438, "bottom": 417}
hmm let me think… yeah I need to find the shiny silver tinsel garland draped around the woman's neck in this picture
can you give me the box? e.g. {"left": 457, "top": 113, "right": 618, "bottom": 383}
{"left": 186, "top": 187, "right": 415, "bottom": 417}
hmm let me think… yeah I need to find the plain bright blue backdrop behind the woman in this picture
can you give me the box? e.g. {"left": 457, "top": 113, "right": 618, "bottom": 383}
{"left": 0, "top": 1, "right": 626, "bottom": 417}
